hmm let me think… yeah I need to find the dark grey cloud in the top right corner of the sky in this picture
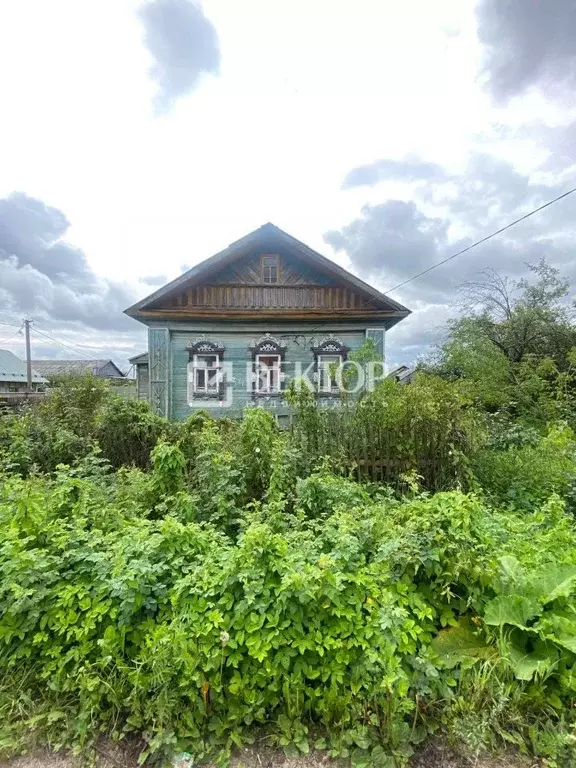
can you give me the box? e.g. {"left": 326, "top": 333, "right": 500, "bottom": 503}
{"left": 477, "top": 0, "right": 576, "bottom": 103}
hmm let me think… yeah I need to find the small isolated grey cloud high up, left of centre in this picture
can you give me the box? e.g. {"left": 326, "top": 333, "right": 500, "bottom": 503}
{"left": 138, "top": 0, "right": 220, "bottom": 113}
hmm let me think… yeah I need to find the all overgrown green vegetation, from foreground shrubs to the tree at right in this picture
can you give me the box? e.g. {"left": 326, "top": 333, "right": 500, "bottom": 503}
{"left": 0, "top": 265, "right": 576, "bottom": 768}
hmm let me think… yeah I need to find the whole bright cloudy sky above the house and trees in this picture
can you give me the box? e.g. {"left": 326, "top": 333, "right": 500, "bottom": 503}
{"left": 0, "top": 0, "right": 576, "bottom": 367}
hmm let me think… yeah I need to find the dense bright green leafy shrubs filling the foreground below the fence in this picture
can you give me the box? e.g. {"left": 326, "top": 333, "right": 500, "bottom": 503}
{"left": 0, "top": 462, "right": 576, "bottom": 766}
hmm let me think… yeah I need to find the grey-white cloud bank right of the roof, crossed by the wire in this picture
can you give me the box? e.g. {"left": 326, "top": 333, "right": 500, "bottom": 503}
{"left": 324, "top": 153, "right": 576, "bottom": 362}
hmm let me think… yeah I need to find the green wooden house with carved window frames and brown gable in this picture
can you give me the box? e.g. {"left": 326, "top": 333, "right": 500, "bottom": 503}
{"left": 125, "top": 224, "right": 410, "bottom": 419}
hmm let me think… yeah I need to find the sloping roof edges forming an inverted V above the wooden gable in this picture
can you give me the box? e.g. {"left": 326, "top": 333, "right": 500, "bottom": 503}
{"left": 124, "top": 222, "right": 410, "bottom": 318}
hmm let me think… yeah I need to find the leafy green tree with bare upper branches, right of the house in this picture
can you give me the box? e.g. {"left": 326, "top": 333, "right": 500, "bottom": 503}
{"left": 434, "top": 260, "right": 576, "bottom": 420}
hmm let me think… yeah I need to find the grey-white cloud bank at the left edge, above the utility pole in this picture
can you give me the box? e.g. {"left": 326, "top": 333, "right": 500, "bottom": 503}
{"left": 0, "top": 193, "right": 135, "bottom": 331}
